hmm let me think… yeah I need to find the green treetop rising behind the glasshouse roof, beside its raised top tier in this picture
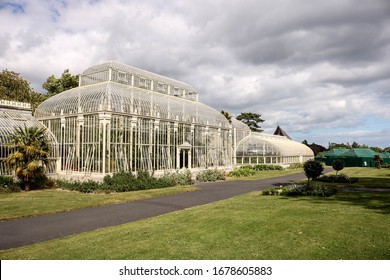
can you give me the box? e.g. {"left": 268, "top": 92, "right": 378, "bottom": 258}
{"left": 42, "top": 69, "right": 79, "bottom": 98}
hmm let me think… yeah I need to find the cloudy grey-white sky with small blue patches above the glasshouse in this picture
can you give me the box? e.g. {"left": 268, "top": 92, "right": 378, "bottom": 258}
{"left": 0, "top": 0, "right": 390, "bottom": 148}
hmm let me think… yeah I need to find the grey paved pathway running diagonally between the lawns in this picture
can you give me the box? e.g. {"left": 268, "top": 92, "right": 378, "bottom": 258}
{"left": 0, "top": 173, "right": 314, "bottom": 250}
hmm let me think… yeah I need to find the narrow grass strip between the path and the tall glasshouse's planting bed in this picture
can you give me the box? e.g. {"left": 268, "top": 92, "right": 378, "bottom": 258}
{"left": 0, "top": 186, "right": 197, "bottom": 220}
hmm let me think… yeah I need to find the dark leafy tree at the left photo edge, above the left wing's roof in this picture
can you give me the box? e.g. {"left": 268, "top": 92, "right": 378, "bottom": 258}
{"left": 0, "top": 70, "right": 43, "bottom": 111}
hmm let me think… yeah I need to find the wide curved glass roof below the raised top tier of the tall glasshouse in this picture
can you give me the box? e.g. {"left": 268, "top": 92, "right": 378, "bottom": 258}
{"left": 35, "top": 82, "right": 230, "bottom": 128}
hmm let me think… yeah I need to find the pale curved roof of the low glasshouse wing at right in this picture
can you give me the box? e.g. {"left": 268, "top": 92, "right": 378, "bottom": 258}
{"left": 237, "top": 133, "right": 314, "bottom": 157}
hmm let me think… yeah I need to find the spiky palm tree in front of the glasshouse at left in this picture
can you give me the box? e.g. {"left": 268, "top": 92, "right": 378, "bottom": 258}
{"left": 5, "top": 125, "right": 50, "bottom": 191}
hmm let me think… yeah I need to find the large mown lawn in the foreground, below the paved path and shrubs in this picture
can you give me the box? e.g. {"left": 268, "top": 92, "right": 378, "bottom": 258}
{"left": 0, "top": 192, "right": 390, "bottom": 260}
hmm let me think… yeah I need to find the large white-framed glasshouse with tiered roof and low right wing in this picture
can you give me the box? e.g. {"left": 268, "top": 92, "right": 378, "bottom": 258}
{"left": 3, "top": 61, "right": 314, "bottom": 177}
